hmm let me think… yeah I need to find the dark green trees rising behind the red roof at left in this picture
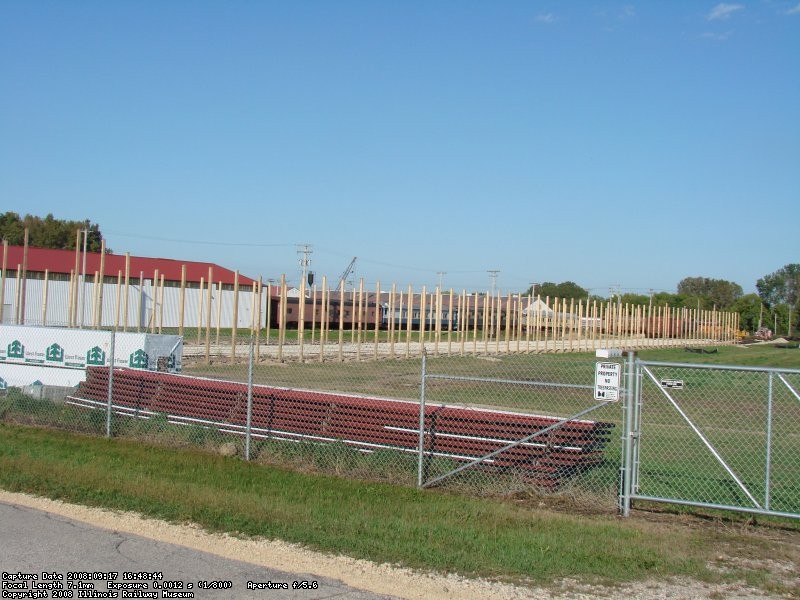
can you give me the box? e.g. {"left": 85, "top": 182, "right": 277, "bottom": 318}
{"left": 0, "top": 212, "right": 111, "bottom": 254}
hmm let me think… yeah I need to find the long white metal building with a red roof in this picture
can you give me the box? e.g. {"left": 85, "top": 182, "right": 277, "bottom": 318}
{"left": 0, "top": 244, "right": 265, "bottom": 331}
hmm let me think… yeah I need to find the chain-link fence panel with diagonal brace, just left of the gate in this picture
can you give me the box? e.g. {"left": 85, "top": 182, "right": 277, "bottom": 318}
{"left": 418, "top": 356, "right": 621, "bottom": 505}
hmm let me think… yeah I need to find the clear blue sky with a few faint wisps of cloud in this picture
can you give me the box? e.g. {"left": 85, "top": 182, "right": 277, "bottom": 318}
{"left": 0, "top": 0, "right": 800, "bottom": 295}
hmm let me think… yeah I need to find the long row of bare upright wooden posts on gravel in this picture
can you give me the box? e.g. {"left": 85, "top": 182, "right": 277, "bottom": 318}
{"left": 0, "top": 237, "right": 739, "bottom": 360}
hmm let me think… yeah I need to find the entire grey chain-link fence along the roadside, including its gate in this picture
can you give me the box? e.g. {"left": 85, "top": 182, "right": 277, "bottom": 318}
{"left": 6, "top": 326, "right": 800, "bottom": 516}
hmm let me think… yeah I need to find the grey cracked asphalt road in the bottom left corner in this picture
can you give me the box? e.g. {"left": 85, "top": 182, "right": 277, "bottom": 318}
{"left": 0, "top": 502, "right": 396, "bottom": 600}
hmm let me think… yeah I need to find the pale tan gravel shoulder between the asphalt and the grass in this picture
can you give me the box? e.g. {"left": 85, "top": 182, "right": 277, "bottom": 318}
{"left": 0, "top": 490, "right": 800, "bottom": 600}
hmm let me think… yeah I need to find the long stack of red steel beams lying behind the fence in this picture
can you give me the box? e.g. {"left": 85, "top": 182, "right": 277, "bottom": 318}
{"left": 68, "top": 367, "right": 614, "bottom": 488}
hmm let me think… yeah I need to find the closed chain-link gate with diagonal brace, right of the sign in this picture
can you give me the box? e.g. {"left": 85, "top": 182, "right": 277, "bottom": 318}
{"left": 621, "top": 360, "right": 800, "bottom": 518}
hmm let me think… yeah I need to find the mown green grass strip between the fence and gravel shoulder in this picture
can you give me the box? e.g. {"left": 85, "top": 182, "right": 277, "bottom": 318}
{"left": 0, "top": 424, "right": 724, "bottom": 582}
